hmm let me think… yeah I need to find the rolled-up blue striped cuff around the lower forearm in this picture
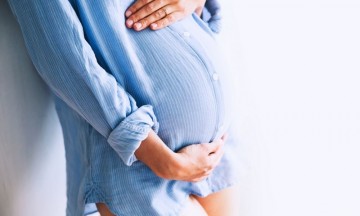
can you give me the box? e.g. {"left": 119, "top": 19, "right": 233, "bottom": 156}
{"left": 107, "top": 105, "right": 159, "bottom": 166}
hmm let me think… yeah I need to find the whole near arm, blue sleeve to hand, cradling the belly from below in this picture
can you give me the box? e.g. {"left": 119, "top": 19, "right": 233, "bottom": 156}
{"left": 8, "top": 0, "right": 226, "bottom": 181}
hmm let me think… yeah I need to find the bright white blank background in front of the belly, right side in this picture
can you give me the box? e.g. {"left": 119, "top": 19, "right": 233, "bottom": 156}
{"left": 218, "top": 0, "right": 360, "bottom": 216}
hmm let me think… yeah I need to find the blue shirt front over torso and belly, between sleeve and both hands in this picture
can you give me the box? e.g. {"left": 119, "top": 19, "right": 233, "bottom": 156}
{"left": 80, "top": 3, "right": 225, "bottom": 150}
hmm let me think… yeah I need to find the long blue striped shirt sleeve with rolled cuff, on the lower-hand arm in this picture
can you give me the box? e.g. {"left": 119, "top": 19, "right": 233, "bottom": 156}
{"left": 8, "top": 0, "right": 158, "bottom": 166}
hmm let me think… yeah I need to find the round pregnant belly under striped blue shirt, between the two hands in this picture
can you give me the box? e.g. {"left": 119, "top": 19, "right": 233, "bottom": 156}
{"left": 125, "top": 16, "right": 224, "bottom": 150}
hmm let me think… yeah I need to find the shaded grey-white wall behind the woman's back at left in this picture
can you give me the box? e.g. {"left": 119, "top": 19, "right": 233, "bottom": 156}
{"left": 0, "top": 0, "right": 65, "bottom": 216}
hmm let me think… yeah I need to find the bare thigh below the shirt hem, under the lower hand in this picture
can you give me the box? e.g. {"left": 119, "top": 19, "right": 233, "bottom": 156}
{"left": 195, "top": 185, "right": 240, "bottom": 216}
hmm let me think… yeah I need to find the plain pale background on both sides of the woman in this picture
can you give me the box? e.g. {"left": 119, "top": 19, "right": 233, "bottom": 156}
{"left": 0, "top": 0, "right": 360, "bottom": 216}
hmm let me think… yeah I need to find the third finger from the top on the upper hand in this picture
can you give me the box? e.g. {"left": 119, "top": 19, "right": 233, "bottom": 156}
{"left": 134, "top": 5, "right": 176, "bottom": 31}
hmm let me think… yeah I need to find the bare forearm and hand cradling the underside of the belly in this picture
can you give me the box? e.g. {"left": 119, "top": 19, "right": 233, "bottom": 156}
{"left": 135, "top": 130, "right": 227, "bottom": 182}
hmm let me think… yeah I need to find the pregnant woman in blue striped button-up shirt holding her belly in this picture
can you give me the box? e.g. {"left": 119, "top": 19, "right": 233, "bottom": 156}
{"left": 9, "top": 0, "right": 238, "bottom": 216}
